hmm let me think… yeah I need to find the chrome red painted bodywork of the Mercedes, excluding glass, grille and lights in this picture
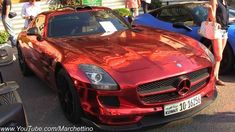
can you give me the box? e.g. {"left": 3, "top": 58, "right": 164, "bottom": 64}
{"left": 18, "top": 8, "right": 215, "bottom": 128}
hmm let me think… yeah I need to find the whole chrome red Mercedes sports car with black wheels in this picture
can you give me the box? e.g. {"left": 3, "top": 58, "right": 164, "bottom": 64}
{"left": 17, "top": 6, "right": 217, "bottom": 131}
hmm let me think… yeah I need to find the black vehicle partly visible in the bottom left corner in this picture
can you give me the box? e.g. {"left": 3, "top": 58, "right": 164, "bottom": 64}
{"left": 0, "top": 72, "right": 28, "bottom": 129}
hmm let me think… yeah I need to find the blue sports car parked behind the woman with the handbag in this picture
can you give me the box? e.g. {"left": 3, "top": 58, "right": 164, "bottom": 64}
{"left": 134, "top": 2, "right": 235, "bottom": 74}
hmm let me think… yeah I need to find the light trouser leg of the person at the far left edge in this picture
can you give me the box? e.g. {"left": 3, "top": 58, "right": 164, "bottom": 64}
{"left": 2, "top": 18, "right": 16, "bottom": 46}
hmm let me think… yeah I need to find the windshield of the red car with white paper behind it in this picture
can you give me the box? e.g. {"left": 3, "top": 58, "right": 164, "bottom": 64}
{"left": 48, "top": 10, "right": 129, "bottom": 37}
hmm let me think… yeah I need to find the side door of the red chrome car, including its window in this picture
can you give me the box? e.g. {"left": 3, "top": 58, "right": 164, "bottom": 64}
{"left": 29, "top": 15, "right": 61, "bottom": 84}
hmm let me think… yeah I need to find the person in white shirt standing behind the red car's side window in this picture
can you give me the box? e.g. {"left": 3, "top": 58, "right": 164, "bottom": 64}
{"left": 21, "top": 0, "right": 41, "bottom": 29}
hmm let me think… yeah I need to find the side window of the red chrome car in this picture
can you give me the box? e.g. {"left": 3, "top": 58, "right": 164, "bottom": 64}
{"left": 33, "top": 15, "right": 46, "bottom": 35}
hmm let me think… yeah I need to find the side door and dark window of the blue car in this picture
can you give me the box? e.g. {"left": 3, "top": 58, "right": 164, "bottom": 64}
{"left": 152, "top": 5, "right": 201, "bottom": 39}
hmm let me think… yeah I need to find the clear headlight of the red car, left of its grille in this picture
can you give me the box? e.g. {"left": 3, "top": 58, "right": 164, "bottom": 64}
{"left": 79, "top": 64, "right": 118, "bottom": 90}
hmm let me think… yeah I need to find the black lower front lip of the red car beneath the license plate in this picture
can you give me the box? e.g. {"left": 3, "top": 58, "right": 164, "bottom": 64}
{"left": 82, "top": 90, "right": 217, "bottom": 131}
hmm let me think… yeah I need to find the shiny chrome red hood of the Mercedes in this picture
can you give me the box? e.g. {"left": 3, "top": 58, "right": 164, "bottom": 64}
{"left": 48, "top": 27, "right": 210, "bottom": 84}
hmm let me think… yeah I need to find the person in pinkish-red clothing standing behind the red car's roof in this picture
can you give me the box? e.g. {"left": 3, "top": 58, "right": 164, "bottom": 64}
{"left": 125, "top": 0, "right": 141, "bottom": 17}
